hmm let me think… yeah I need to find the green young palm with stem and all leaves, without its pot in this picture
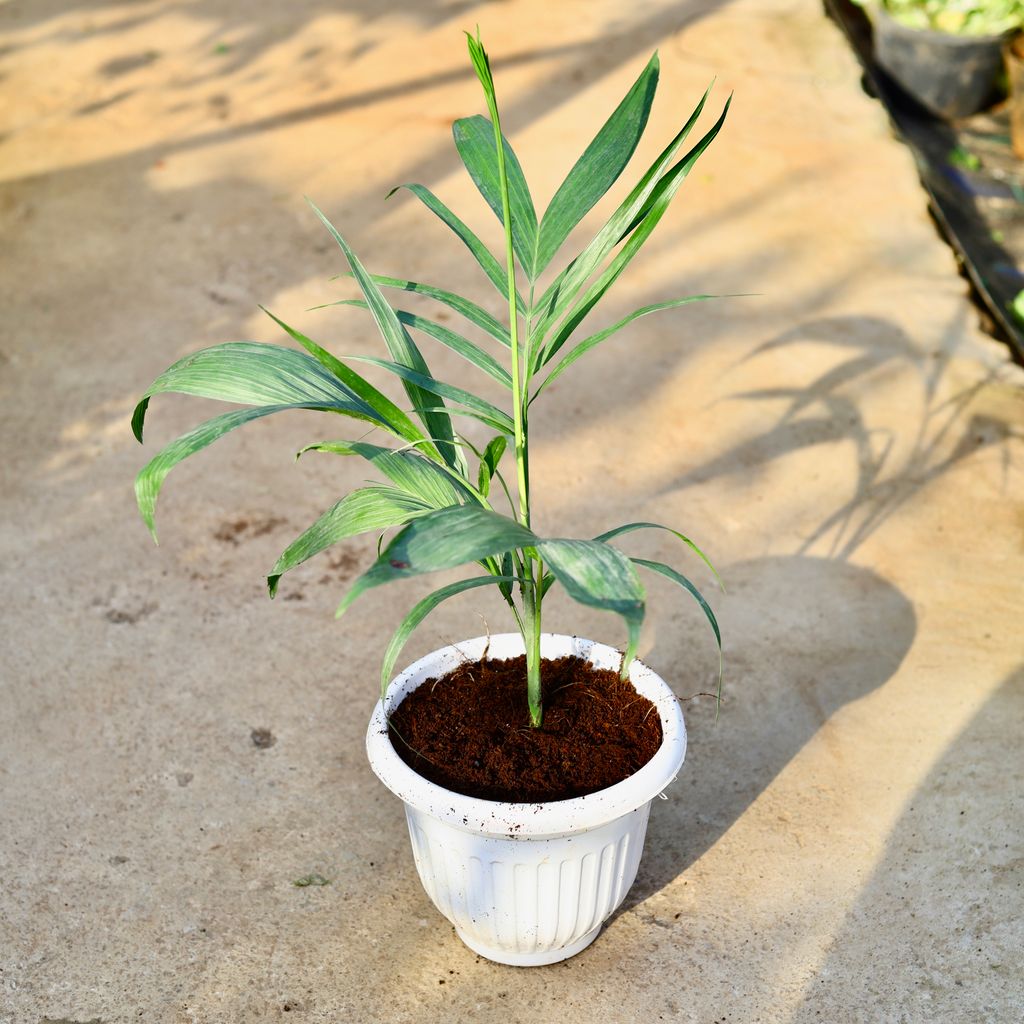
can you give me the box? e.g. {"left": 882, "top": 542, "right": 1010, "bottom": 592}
{"left": 132, "top": 36, "right": 729, "bottom": 726}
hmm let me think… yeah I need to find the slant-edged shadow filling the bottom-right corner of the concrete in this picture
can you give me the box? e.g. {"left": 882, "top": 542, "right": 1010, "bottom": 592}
{"left": 792, "top": 667, "right": 1024, "bottom": 1024}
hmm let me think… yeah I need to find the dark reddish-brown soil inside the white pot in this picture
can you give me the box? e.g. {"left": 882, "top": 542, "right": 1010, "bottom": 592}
{"left": 391, "top": 655, "right": 662, "bottom": 804}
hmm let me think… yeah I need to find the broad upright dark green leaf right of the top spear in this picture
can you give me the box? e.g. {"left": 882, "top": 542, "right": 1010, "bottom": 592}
{"left": 537, "top": 53, "right": 658, "bottom": 273}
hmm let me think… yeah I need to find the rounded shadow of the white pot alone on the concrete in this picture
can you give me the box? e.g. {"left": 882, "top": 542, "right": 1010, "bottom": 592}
{"left": 620, "top": 555, "right": 916, "bottom": 912}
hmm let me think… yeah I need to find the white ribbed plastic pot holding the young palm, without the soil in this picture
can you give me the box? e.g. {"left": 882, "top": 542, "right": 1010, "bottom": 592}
{"left": 367, "top": 633, "right": 686, "bottom": 967}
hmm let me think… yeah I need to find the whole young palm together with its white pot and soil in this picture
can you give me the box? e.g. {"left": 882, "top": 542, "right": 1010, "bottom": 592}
{"left": 133, "top": 29, "right": 728, "bottom": 965}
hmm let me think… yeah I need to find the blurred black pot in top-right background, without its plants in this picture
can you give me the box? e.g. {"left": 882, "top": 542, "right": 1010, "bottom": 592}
{"left": 870, "top": 6, "right": 1006, "bottom": 120}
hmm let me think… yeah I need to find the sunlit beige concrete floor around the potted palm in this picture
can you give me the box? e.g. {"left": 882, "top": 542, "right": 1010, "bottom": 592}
{"left": 0, "top": 0, "right": 1024, "bottom": 1024}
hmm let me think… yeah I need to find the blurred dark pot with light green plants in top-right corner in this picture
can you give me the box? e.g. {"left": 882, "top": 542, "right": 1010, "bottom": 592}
{"left": 854, "top": 0, "right": 1024, "bottom": 118}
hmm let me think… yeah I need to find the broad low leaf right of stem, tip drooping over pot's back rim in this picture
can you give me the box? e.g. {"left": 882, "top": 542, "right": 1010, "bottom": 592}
{"left": 536, "top": 540, "right": 644, "bottom": 679}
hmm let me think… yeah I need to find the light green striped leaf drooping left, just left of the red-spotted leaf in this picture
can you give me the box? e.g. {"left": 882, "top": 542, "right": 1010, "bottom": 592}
{"left": 266, "top": 486, "right": 431, "bottom": 597}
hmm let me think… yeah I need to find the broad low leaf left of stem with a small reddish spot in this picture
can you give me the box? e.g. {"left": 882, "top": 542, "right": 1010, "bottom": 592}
{"left": 338, "top": 505, "right": 537, "bottom": 615}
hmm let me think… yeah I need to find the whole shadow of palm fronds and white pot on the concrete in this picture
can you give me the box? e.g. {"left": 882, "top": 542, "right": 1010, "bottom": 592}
{"left": 620, "top": 316, "right": 1022, "bottom": 912}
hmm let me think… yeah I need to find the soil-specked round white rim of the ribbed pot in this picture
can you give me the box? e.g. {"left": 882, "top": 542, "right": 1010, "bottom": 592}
{"left": 367, "top": 633, "right": 686, "bottom": 839}
